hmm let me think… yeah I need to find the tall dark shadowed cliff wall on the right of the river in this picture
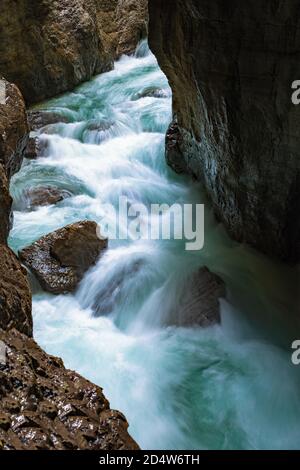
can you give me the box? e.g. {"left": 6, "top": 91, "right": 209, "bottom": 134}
{"left": 149, "top": 0, "right": 300, "bottom": 262}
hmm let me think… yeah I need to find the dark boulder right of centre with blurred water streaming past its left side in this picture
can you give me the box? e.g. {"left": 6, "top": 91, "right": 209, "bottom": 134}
{"left": 166, "top": 267, "right": 226, "bottom": 328}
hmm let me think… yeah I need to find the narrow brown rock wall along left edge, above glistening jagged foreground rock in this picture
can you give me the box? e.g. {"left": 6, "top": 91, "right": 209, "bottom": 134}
{"left": 0, "top": 81, "right": 32, "bottom": 336}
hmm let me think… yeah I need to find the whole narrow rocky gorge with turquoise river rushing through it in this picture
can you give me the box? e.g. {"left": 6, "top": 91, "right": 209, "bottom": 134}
{"left": 0, "top": 0, "right": 300, "bottom": 450}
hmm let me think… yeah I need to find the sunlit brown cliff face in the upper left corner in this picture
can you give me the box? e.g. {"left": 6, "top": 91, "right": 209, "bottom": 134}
{"left": 0, "top": 0, "right": 147, "bottom": 103}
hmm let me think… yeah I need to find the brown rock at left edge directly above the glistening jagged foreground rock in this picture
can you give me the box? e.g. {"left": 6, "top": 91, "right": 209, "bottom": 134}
{"left": 0, "top": 244, "right": 32, "bottom": 336}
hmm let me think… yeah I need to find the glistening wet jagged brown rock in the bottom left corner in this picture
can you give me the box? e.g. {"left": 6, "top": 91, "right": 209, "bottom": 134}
{"left": 0, "top": 330, "right": 138, "bottom": 450}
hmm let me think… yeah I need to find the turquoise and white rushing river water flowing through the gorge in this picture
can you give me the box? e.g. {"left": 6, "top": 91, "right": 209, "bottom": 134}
{"left": 10, "top": 44, "right": 300, "bottom": 449}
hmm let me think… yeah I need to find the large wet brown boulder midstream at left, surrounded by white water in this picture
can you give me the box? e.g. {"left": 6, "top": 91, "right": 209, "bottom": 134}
{"left": 19, "top": 221, "right": 107, "bottom": 294}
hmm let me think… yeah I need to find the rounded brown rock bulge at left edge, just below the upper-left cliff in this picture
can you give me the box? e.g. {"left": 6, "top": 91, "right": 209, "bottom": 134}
{"left": 0, "top": 77, "right": 28, "bottom": 180}
